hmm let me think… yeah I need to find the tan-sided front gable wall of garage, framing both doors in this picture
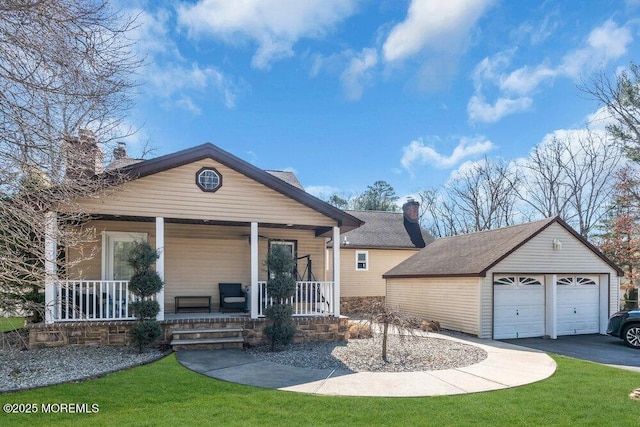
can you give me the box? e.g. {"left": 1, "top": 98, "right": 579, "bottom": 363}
{"left": 479, "top": 223, "right": 618, "bottom": 338}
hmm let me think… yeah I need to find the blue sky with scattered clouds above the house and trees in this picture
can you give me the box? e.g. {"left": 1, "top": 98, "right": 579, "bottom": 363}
{"left": 124, "top": 0, "right": 640, "bottom": 199}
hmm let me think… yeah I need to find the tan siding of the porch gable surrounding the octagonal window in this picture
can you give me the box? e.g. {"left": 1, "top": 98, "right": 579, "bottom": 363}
{"left": 74, "top": 159, "right": 336, "bottom": 227}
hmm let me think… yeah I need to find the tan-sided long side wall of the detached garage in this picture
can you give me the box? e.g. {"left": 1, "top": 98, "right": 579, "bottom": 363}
{"left": 386, "top": 277, "right": 480, "bottom": 335}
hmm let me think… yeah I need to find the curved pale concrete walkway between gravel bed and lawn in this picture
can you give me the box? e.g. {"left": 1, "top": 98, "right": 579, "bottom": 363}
{"left": 176, "top": 333, "right": 556, "bottom": 397}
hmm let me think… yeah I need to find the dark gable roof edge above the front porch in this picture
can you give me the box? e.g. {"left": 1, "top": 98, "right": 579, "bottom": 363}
{"left": 112, "top": 142, "right": 362, "bottom": 235}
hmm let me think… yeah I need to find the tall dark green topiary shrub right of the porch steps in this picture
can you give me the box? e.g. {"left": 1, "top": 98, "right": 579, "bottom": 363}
{"left": 263, "top": 245, "right": 296, "bottom": 351}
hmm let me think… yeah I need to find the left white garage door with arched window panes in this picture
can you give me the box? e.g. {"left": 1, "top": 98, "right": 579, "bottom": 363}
{"left": 493, "top": 275, "right": 545, "bottom": 339}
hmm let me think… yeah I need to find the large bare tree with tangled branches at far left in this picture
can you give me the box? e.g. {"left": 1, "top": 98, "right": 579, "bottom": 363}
{"left": 0, "top": 0, "right": 141, "bottom": 320}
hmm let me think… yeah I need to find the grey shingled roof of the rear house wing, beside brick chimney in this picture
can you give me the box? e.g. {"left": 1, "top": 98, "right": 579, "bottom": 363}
{"left": 329, "top": 211, "right": 434, "bottom": 249}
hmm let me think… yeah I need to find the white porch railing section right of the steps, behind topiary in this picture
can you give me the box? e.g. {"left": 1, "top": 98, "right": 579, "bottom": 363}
{"left": 258, "top": 281, "right": 335, "bottom": 317}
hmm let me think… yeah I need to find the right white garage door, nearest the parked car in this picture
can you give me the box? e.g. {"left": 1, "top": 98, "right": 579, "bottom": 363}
{"left": 556, "top": 276, "right": 600, "bottom": 335}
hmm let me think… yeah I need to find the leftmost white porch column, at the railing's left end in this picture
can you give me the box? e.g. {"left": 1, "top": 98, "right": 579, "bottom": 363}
{"left": 44, "top": 212, "right": 58, "bottom": 324}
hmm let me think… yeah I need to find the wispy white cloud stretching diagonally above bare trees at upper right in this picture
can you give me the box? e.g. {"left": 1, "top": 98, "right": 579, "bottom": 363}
{"left": 467, "top": 20, "right": 633, "bottom": 123}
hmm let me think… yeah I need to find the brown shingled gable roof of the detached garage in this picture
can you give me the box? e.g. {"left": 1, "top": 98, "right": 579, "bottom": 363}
{"left": 382, "top": 217, "right": 624, "bottom": 278}
